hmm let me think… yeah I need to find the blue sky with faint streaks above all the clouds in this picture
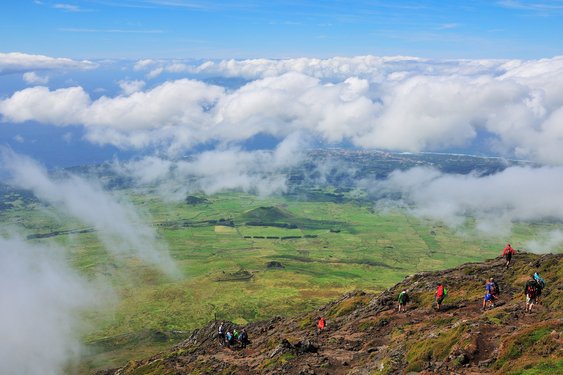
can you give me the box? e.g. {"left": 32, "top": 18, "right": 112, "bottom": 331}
{"left": 0, "top": 0, "right": 563, "bottom": 59}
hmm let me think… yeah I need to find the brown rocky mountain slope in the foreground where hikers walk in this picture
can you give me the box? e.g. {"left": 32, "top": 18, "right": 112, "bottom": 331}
{"left": 100, "top": 253, "right": 563, "bottom": 374}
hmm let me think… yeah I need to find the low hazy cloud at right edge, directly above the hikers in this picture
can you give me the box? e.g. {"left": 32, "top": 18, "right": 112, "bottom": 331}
{"left": 373, "top": 167, "right": 563, "bottom": 249}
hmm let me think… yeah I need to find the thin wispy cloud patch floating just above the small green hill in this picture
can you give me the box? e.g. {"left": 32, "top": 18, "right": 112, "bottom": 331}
{"left": 113, "top": 133, "right": 307, "bottom": 201}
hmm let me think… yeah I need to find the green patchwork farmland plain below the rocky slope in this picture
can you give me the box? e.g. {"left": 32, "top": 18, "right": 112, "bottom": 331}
{"left": 1, "top": 192, "right": 560, "bottom": 371}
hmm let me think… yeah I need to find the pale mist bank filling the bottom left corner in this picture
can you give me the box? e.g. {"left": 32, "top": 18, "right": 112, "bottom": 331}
{"left": 0, "top": 237, "right": 95, "bottom": 375}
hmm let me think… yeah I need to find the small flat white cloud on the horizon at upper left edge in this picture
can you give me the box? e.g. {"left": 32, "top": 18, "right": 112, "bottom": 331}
{"left": 0, "top": 52, "right": 98, "bottom": 74}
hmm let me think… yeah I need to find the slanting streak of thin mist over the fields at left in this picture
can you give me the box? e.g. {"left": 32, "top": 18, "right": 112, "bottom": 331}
{"left": 0, "top": 149, "right": 176, "bottom": 274}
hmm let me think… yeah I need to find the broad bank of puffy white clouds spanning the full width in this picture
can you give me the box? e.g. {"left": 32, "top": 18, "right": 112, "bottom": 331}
{"left": 0, "top": 56, "right": 563, "bottom": 165}
